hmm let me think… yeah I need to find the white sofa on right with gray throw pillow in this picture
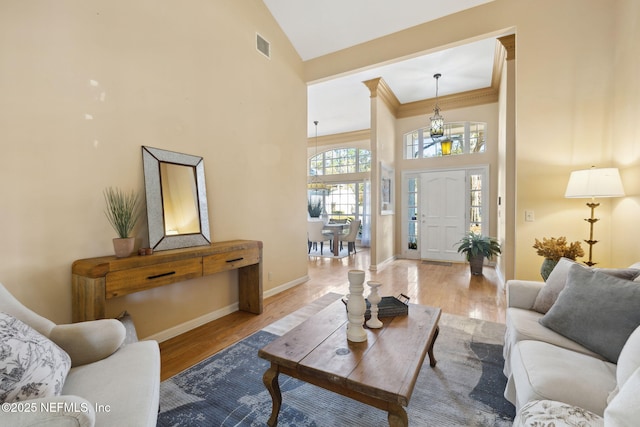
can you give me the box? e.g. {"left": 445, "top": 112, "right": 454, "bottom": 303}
{"left": 504, "top": 259, "right": 640, "bottom": 427}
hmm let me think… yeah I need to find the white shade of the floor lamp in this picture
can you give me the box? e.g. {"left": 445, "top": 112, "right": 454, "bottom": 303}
{"left": 564, "top": 168, "right": 624, "bottom": 199}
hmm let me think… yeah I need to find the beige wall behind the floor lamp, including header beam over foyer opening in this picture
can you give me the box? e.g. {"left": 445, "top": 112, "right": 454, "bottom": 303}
{"left": 305, "top": 0, "right": 640, "bottom": 279}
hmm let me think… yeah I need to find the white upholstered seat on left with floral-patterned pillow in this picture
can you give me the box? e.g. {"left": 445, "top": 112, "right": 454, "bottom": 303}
{"left": 0, "top": 284, "right": 160, "bottom": 427}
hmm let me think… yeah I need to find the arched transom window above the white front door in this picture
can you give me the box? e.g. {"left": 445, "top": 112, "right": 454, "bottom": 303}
{"left": 403, "top": 122, "right": 487, "bottom": 159}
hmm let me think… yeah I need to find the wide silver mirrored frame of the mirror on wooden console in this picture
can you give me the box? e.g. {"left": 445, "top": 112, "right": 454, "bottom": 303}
{"left": 142, "top": 146, "right": 211, "bottom": 250}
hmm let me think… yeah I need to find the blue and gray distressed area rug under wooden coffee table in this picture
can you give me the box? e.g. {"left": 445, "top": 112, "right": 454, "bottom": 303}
{"left": 158, "top": 294, "right": 514, "bottom": 427}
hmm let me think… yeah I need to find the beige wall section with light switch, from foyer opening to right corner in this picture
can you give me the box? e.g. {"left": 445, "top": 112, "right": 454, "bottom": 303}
{"left": 516, "top": 1, "right": 640, "bottom": 278}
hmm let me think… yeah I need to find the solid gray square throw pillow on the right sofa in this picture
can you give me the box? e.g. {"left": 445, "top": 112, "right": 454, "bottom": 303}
{"left": 539, "top": 265, "right": 640, "bottom": 363}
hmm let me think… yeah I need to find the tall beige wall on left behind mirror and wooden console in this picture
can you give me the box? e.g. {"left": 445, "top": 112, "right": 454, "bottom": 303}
{"left": 0, "top": 0, "right": 307, "bottom": 337}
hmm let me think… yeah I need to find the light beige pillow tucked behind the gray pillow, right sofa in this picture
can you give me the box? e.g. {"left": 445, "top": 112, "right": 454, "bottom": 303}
{"left": 532, "top": 258, "right": 640, "bottom": 314}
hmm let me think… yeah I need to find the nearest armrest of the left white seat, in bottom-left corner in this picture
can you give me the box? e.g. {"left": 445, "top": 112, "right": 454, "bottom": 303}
{"left": 0, "top": 395, "right": 96, "bottom": 427}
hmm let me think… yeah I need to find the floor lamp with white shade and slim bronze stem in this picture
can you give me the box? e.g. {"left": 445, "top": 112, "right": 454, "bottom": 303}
{"left": 564, "top": 167, "right": 624, "bottom": 267}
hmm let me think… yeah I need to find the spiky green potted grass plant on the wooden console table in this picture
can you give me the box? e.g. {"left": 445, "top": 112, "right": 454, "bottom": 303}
{"left": 104, "top": 187, "right": 140, "bottom": 258}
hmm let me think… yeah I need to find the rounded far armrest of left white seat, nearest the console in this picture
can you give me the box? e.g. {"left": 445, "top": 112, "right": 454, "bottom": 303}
{"left": 49, "top": 319, "right": 127, "bottom": 367}
